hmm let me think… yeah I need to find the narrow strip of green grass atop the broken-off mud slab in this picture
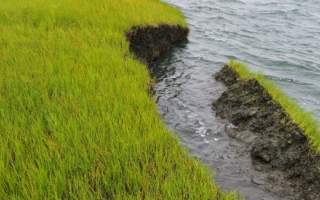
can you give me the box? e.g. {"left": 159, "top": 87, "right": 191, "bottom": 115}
{"left": 228, "top": 61, "right": 320, "bottom": 152}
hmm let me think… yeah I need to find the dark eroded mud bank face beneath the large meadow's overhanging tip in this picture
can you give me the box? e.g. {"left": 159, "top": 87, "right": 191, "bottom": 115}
{"left": 126, "top": 24, "right": 189, "bottom": 63}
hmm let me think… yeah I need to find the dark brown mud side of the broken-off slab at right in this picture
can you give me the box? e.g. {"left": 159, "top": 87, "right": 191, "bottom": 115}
{"left": 213, "top": 65, "right": 320, "bottom": 200}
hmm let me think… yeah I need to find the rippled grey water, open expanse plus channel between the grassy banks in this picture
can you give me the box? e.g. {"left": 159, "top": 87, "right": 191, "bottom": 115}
{"left": 150, "top": 0, "right": 320, "bottom": 200}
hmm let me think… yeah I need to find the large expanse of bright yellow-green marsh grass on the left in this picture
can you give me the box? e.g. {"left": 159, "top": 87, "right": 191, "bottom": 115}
{"left": 0, "top": 0, "right": 239, "bottom": 199}
